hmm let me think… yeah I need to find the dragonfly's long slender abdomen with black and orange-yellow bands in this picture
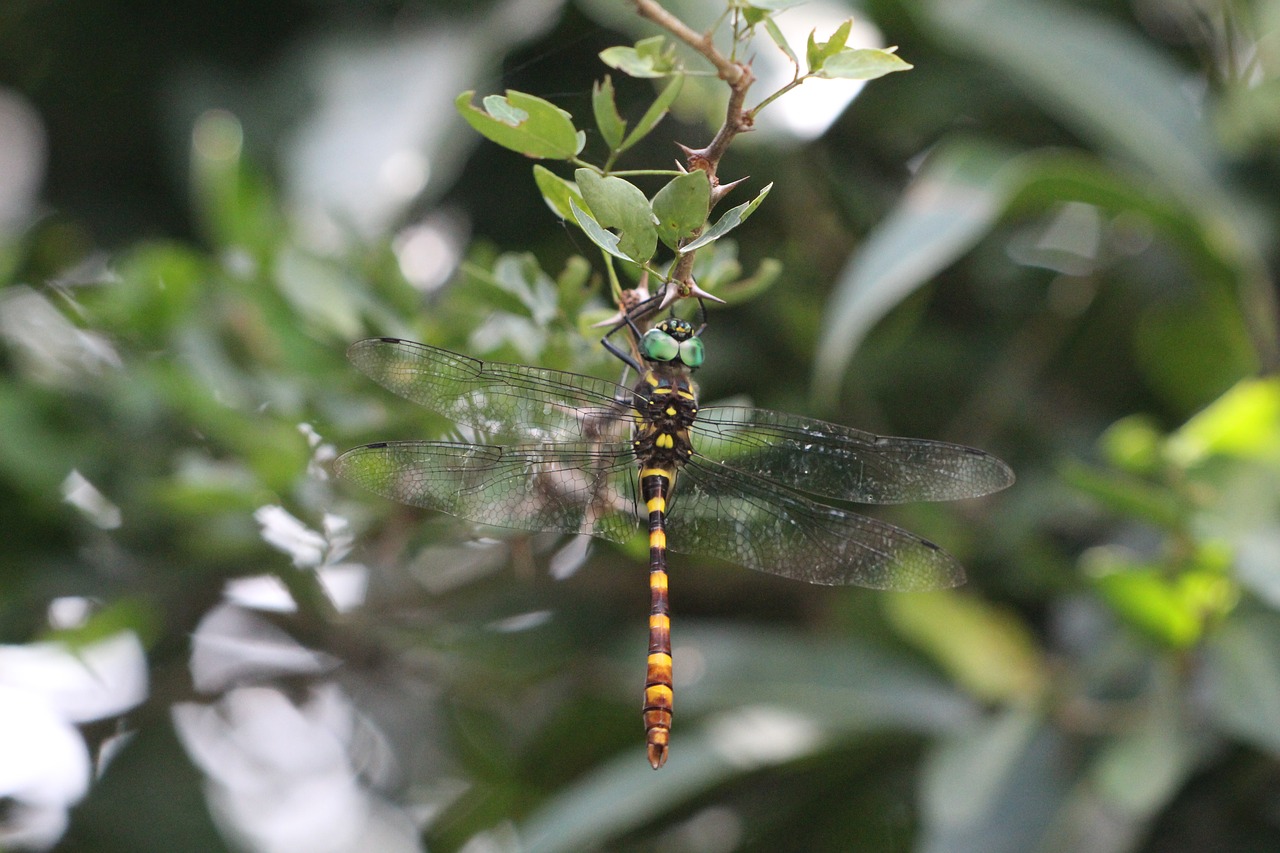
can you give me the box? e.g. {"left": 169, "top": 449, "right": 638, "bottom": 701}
{"left": 640, "top": 467, "right": 675, "bottom": 770}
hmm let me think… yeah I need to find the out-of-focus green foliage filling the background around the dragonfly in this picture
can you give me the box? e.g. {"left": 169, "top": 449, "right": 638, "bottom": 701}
{"left": 0, "top": 0, "right": 1280, "bottom": 853}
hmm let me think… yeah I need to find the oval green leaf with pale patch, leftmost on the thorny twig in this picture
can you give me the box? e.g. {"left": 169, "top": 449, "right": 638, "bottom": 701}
{"left": 454, "top": 90, "right": 586, "bottom": 160}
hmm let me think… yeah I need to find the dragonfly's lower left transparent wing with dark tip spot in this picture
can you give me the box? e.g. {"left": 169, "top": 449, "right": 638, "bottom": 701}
{"left": 333, "top": 442, "right": 640, "bottom": 542}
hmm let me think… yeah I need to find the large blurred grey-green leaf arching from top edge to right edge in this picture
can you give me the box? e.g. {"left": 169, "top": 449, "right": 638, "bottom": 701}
{"left": 910, "top": 0, "right": 1280, "bottom": 361}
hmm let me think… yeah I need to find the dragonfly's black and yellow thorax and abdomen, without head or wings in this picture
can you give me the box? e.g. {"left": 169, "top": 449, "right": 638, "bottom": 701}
{"left": 632, "top": 365, "right": 698, "bottom": 770}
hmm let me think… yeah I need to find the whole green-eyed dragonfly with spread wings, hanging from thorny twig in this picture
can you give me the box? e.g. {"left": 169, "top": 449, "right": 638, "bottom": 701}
{"left": 334, "top": 315, "right": 1014, "bottom": 770}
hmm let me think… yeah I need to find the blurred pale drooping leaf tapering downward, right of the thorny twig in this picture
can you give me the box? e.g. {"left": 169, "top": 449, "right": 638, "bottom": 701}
{"left": 814, "top": 140, "right": 1019, "bottom": 397}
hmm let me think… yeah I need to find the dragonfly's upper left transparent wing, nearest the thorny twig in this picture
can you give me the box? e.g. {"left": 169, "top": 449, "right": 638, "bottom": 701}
{"left": 347, "top": 338, "right": 631, "bottom": 442}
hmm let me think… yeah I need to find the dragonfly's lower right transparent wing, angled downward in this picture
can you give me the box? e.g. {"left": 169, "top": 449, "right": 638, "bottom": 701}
{"left": 667, "top": 459, "right": 964, "bottom": 590}
